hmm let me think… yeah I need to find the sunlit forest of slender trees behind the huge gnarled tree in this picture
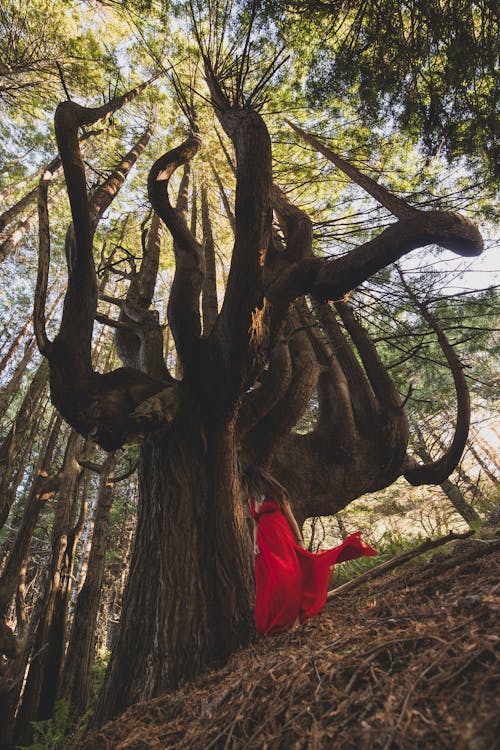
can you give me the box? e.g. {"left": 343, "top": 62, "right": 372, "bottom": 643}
{"left": 0, "top": 0, "right": 499, "bottom": 747}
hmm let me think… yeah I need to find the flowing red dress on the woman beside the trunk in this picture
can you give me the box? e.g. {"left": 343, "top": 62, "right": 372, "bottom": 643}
{"left": 250, "top": 498, "right": 377, "bottom": 635}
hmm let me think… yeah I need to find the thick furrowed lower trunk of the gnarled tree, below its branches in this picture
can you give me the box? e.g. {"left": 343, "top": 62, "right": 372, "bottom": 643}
{"left": 93, "top": 410, "right": 253, "bottom": 727}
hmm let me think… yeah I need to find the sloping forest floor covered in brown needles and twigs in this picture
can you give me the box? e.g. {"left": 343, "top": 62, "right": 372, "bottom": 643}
{"left": 80, "top": 539, "right": 500, "bottom": 750}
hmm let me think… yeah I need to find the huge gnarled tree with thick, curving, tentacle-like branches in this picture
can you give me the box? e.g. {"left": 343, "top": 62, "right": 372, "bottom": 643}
{"left": 23, "top": 1, "right": 482, "bottom": 724}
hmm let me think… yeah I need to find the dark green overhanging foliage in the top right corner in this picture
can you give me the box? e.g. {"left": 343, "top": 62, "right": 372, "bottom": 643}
{"left": 263, "top": 0, "right": 499, "bottom": 184}
